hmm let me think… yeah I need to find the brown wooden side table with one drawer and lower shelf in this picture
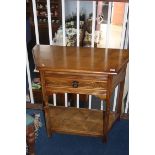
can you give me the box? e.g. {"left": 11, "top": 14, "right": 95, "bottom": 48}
{"left": 33, "top": 45, "right": 129, "bottom": 141}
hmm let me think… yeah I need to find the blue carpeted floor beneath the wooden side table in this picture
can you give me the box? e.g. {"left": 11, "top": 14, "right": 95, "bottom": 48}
{"left": 27, "top": 110, "right": 129, "bottom": 155}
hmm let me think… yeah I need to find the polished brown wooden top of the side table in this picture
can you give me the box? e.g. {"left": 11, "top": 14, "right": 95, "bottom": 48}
{"left": 33, "top": 45, "right": 129, "bottom": 74}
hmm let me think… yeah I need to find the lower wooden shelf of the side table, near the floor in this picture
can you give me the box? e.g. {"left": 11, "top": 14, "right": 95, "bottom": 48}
{"left": 49, "top": 106, "right": 118, "bottom": 136}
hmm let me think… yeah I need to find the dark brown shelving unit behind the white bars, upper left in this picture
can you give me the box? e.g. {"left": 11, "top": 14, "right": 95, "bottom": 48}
{"left": 26, "top": 0, "right": 61, "bottom": 44}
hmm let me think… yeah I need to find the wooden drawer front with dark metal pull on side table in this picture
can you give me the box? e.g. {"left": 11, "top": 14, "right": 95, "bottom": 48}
{"left": 44, "top": 73, "right": 107, "bottom": 95}
